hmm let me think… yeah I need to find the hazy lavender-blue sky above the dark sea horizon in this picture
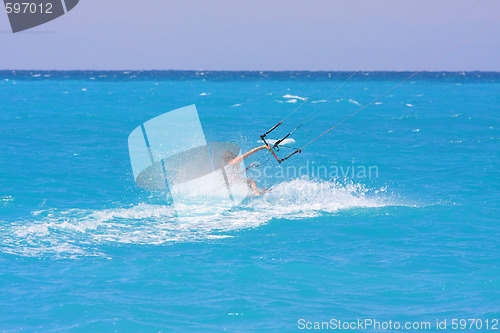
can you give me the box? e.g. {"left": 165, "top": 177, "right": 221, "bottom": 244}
{"left": 0, "top": 0, "right": 500, "bottom": 71}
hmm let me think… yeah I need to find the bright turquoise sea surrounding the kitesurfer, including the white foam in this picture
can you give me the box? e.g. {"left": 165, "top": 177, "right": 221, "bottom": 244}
{"left": 0, "top": 71, "right": 500, "bottom": 332}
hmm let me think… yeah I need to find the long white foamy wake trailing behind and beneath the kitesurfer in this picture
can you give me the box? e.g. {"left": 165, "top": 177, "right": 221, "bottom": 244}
{"left": 0, "top": 178, "right": 394, "bottom": 258}
